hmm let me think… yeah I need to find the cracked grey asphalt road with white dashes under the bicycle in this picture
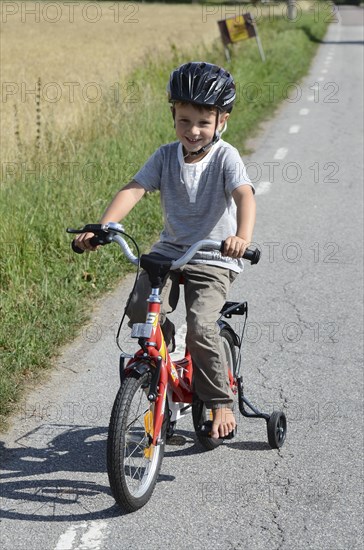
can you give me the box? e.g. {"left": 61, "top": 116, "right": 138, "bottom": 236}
{"left": 0, "top": 8, "right": 363, "bottom": 550}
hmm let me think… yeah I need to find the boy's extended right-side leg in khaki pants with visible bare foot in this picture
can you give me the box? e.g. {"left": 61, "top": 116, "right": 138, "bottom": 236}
{"left": 183, "top": 264, "right": 236, "bottom": 437}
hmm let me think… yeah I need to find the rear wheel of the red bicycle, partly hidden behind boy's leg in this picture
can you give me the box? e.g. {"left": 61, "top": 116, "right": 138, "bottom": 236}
{"left": 192, "top": 328, "right": 237, "bottom": 451}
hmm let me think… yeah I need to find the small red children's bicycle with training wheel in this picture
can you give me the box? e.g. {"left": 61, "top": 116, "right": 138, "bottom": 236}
{"left": 67, "top": 223, "right": 287, "bottom": 512}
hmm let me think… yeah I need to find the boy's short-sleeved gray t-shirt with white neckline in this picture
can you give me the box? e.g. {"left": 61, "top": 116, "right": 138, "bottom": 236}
{"left": 133, "top": 139, "right": 254, "bottom": 272}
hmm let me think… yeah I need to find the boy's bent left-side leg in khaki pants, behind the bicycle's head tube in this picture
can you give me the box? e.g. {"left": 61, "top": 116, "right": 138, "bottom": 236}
{"left": 126, "top": 271, "right": 179, "bottom": 351}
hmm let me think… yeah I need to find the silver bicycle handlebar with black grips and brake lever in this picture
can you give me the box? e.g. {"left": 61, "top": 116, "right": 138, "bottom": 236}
{"left": 66, "top": 222, "right": 260, "bottom": 269}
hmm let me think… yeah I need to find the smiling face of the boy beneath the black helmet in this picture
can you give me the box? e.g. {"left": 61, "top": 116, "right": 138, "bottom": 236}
{"left": 175, "top": 103, "right": 229, "bottom": 159}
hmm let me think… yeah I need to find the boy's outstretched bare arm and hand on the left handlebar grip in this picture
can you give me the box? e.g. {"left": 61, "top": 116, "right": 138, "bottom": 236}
{"left": 75, "top": 180, "right": 145, "bottom": 250}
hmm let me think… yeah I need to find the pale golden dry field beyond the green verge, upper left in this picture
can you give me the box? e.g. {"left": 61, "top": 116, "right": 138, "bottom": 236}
{"left": 0, "top": 2, "right": 226, "bottom": 160}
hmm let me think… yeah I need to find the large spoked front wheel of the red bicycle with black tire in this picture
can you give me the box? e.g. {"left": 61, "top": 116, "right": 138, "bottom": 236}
{"left": 107, "top": 373, "right": 167, "bottom": 512}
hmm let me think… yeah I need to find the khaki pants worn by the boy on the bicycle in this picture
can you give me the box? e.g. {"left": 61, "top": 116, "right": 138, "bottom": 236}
{"left": 127, "top": 264, "right": 237, "bottom": 408}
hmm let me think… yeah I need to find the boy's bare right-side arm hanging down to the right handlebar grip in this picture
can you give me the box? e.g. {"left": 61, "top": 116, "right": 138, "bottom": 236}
{"left": 224, "top": 185, "right": 256, "bottom": 258}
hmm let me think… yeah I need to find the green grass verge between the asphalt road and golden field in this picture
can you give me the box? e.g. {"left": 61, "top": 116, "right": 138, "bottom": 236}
{"left": 0, "top": 9, "right": 326, "bottom": 432}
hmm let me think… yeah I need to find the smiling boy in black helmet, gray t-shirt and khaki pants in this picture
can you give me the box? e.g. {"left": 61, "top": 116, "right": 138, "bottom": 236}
{"left": 76, "top": 62, "right": 255, "bottom": 438}
